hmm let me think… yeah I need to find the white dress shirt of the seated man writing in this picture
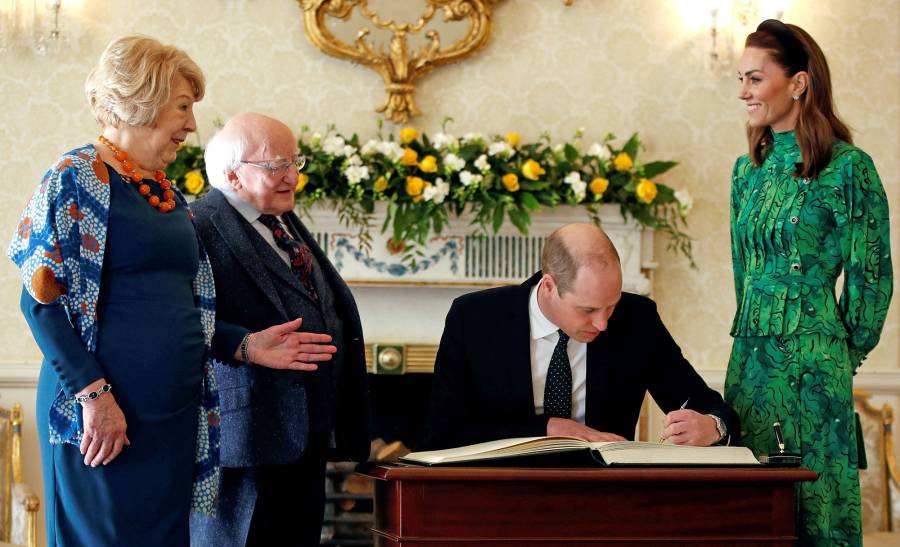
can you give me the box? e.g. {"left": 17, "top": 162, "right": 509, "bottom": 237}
{"left": 528, "top": 282, "right": 587, "bottom": 424}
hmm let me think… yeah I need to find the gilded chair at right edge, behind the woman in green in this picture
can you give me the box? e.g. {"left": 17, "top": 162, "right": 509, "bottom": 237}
{"left": 853, "top": 389, "right": 900, "bottom": 547}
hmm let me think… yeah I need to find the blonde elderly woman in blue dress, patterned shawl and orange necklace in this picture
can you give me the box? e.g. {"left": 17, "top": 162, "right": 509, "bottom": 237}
{"left": 8, "top": 36, "right": 333, "bottom": 546}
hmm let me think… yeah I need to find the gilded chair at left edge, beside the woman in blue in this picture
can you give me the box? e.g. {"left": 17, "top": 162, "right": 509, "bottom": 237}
{"left": 0, "top": 403, "right": 40, "bottom": 547}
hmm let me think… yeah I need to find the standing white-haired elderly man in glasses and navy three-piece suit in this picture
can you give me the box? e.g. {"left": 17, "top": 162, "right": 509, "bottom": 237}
{"left": 191, "top": 114, "right": 369, "bottom": 547}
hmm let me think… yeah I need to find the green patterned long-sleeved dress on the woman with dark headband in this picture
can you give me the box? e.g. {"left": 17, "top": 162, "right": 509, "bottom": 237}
{"left": 725, "top": 131, "right": 893, "bottom": 546}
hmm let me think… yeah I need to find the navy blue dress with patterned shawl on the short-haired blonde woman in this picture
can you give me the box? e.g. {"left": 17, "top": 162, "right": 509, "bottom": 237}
{"left": 8, "top": 146, "right": 236, "bottom": 546}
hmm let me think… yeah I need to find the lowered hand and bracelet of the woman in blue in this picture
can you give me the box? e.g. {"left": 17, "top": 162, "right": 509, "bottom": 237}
{"left": 75, "top": 378, "right": 131, "bottom": 467}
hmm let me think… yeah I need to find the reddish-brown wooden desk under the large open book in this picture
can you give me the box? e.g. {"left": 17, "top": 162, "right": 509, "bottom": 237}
{"left": 358, "top": 464, "right": 816, "bottom": 547}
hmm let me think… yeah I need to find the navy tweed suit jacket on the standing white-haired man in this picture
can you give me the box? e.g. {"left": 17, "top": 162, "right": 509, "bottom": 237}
{"left": 191, "top": 189, "right": 370, "bottom": 545}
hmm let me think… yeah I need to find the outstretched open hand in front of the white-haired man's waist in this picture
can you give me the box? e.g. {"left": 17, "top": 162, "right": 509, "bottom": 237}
{"left": 247, "top": 318, "right": 337, "bottom": 371}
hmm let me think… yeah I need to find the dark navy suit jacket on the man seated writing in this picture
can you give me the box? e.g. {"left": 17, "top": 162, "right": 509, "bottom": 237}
{"left": 424, "top": 272, "right": 740, "bottom": 448}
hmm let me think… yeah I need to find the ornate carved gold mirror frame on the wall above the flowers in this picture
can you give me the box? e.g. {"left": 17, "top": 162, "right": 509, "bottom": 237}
{"left": 298, "top": 0, "right": 574, "bottom": 123}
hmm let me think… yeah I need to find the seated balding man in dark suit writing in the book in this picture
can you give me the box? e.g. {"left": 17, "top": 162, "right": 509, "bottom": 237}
{"left": 425, "top": 224, "right": 740, "bottom": 448}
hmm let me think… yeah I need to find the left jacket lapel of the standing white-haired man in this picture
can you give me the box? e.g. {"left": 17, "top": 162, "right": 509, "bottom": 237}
{"left": 207, "top": 190, "right": 287, "bottom": 317}
